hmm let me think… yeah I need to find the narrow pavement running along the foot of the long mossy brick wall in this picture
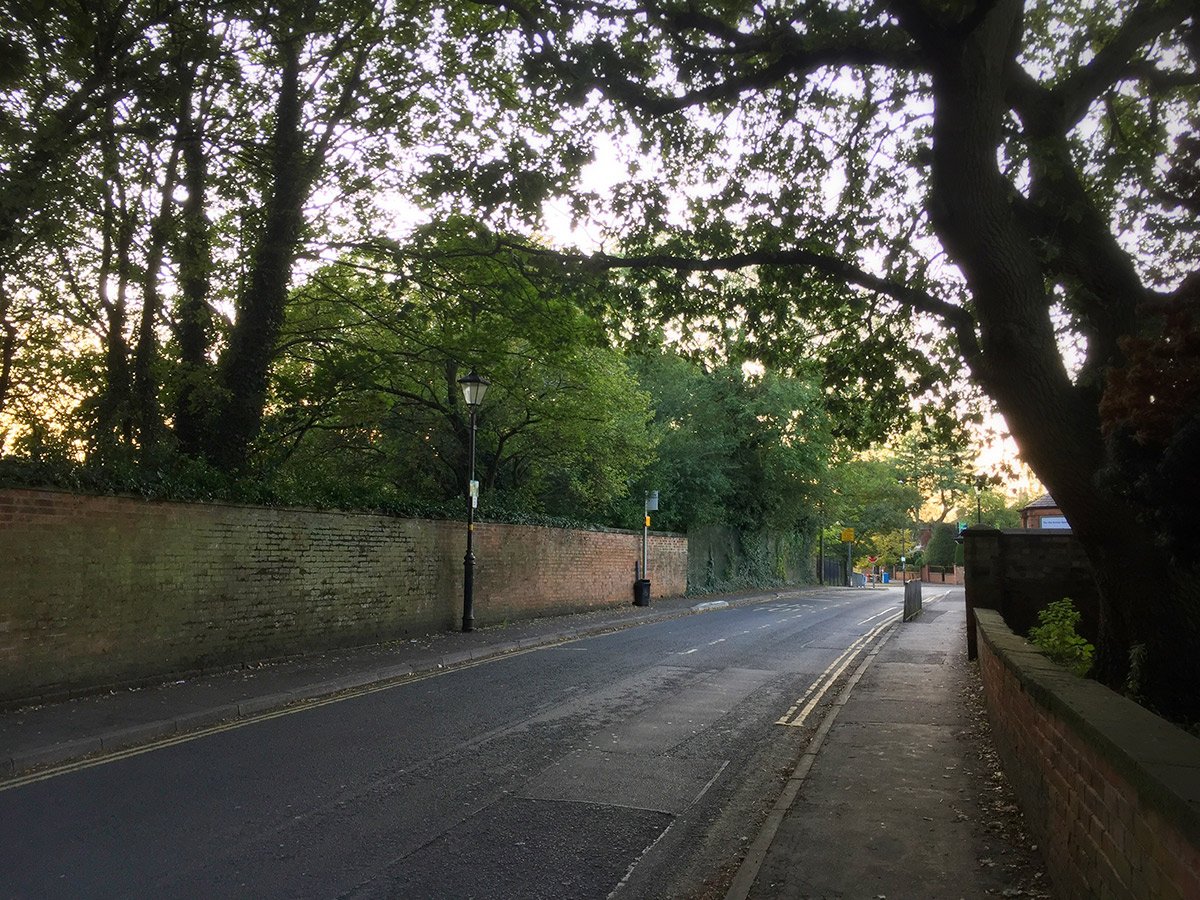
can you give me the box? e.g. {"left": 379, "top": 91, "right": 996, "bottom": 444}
{"left": 0, "top": 588, "right": 787, "bottom": 785}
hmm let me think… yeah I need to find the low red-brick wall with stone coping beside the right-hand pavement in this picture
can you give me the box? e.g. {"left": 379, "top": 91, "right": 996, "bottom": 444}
{"left": 976, "top": 610, "right": 1200, "bottom": 900}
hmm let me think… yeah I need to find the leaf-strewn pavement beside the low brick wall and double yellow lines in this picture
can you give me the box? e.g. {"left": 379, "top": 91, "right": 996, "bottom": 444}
{"left": 727, "top": 586, "right": 1049, "bottom": 900}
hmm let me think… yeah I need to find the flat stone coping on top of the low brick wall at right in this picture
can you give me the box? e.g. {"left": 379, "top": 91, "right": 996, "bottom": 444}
{"left": 974, "top": 608, "right": 1200, "bottom": 846}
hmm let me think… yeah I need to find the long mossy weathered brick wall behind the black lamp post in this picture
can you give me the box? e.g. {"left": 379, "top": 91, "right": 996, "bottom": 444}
{"left": 0, "top": 490, "right": 688, "bottom": 701}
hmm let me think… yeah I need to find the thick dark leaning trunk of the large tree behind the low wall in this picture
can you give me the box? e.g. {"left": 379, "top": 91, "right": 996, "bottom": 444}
{"left": 912, "top": 0, "right": 1200, "bottom": 720}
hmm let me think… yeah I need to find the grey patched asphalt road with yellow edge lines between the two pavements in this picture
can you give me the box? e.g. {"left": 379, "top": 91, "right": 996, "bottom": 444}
{"left": 0, "top": 587, "right": 902, "bottom": 898}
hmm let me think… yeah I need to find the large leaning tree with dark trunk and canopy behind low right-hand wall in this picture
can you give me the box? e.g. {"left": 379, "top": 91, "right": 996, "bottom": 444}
{"left": 493, "top": 0, "right": 1200, "bottom": 719}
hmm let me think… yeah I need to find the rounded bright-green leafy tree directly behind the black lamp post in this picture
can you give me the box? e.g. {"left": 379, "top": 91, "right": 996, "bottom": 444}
{"left": 258, "top": 221, "right": 653, "bottom": 521}
